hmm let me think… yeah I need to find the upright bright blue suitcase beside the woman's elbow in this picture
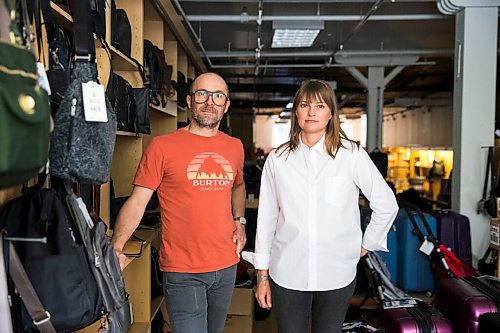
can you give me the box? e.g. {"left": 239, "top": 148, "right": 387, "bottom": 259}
{"left": 394, "top": 209, "right": 436, "bottom": 292}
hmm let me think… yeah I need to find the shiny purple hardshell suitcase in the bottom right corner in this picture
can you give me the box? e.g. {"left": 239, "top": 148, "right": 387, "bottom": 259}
{"left": 434, "top": 277, "right": 500, "bottom": 333}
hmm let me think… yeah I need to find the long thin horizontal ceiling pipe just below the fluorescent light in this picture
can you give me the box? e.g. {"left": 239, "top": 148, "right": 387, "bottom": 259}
{"left": 207, "top": 49, "right": 454, "bottom": 59}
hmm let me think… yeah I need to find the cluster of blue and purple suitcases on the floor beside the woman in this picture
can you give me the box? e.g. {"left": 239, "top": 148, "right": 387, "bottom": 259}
{"left": 363, "top": 203, "right": 500, "bottom": 333}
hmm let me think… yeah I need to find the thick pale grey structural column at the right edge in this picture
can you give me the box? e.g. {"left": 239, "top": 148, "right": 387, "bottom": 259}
{"left": 438, "top": 0, "right": 500, "bottom": 259}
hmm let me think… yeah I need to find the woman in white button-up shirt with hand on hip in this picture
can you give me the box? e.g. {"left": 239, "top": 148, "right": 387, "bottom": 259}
{"left": 243, "top": 80, "right": 398, "bottom": 333}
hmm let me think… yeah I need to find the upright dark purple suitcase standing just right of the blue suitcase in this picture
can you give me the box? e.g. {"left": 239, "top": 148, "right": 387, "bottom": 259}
{"left": 432, "top": 210, "right": 472, "bottom": 264}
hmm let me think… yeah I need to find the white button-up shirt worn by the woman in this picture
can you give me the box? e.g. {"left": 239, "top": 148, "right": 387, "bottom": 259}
{"left": 243, "top": 136, "right": 398, "bottom": 291}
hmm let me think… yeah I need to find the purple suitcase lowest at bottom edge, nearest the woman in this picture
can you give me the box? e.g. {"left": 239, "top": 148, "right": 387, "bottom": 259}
{"left": 378, "top": 302, "right": 453, "bottom": 333}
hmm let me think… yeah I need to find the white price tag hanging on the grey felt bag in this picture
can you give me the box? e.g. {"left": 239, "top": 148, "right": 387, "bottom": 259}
{"left": 82, "top": 81, "right": 108, "bottom": 123}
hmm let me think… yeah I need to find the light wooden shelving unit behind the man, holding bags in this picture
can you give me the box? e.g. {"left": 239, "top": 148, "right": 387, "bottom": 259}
{"left": 43, "top": 0, "right": 205, "bottom": 333}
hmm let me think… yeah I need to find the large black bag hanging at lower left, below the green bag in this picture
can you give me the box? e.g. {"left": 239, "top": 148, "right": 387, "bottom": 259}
{"left": 0, "top": 178, "right": 102, "bottom": 332}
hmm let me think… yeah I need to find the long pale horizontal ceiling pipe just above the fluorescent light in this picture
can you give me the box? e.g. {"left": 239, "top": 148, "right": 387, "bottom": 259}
{"left": 185, "top": 13, "right": 450, "bottom": 23}
